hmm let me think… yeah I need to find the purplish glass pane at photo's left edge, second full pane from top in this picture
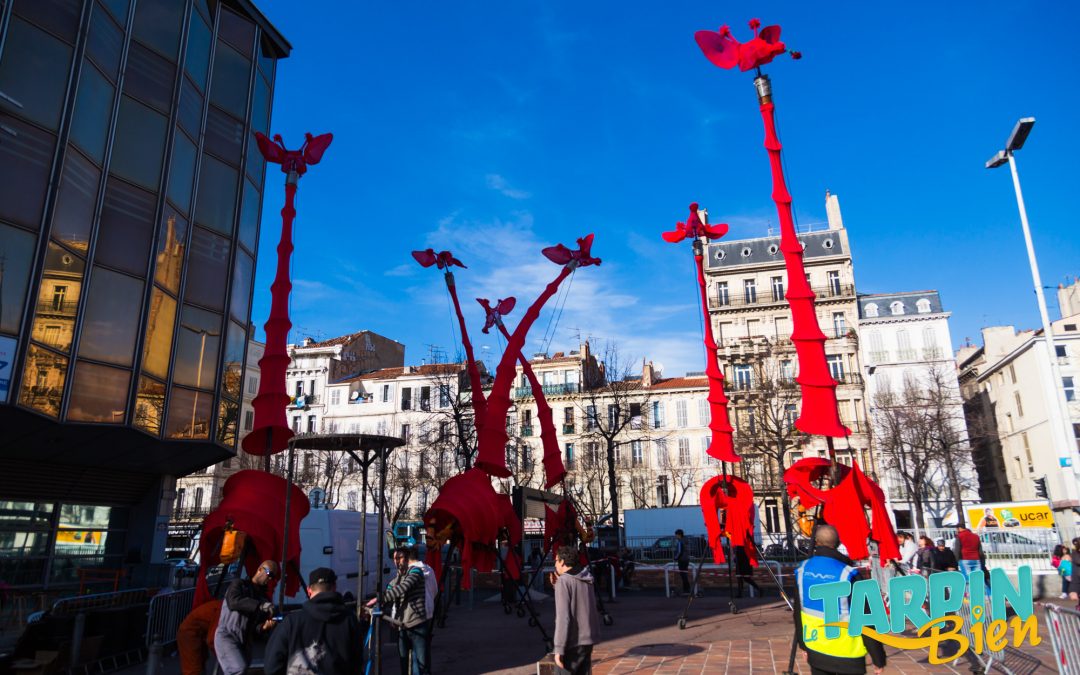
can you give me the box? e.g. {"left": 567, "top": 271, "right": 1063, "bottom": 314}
{"left": 0, "top": 111, "right": 56, "bottom": 230}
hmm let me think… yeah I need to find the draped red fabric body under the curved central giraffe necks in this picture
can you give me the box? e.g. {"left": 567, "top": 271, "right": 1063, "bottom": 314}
{"left": 423, "top": 468, "right": 522, "bottom": 589}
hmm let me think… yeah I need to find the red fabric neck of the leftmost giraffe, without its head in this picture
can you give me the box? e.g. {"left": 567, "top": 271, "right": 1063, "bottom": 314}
{"left": 241, "top": 183, "right": 296, "bottom": 455}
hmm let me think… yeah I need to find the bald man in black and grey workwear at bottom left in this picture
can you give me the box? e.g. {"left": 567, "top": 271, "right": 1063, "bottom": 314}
{"left": 214, "top": 561, "right": 278, "bottom": 675}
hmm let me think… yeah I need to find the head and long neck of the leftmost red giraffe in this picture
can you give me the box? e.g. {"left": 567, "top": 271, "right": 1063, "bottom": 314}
{"left": 241, "top": 132, "right": 334, "bottom": 455}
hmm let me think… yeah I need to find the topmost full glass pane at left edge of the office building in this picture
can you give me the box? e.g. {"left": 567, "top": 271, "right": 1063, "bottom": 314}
{"left": 0, "top": 16, "right": 72, "bottom": 131}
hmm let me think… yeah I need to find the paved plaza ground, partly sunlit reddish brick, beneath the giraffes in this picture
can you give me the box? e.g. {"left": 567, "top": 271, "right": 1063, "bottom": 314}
{"left": 130, "top": 590, "right": 1057, "bottom": 675}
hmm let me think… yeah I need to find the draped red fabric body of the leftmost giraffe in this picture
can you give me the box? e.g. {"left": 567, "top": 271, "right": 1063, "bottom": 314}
{"left": 194, "top": 470, "right": 311, "bottom": 606}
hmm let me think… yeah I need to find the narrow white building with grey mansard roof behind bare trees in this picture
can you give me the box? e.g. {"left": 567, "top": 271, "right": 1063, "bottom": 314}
{"left": 859, "top": 291, "right": 978, "bottom": 529}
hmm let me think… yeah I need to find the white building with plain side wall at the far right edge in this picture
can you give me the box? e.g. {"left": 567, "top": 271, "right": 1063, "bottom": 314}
{"left": 957, "top": 284, "right": 1080, "bottom": 531}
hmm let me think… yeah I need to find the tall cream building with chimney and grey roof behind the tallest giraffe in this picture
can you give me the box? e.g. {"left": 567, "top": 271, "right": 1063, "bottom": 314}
{"left": 705, "top": 193, "right": 878, "bottom": 492}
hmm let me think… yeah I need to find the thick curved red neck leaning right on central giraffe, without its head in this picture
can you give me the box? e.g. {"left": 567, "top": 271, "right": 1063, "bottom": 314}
{"left": 476, "top": 266, "right": 572, "bottom": 478}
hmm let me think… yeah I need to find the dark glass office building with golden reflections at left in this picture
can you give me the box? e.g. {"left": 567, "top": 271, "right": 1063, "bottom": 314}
{"left": 0, "top": 0, "right": 291, "bottom": 586}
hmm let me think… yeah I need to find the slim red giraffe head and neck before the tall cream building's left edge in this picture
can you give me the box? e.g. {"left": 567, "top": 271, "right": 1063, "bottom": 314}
{"left": 662, "top": 202, "right": 739, "bottom": 460}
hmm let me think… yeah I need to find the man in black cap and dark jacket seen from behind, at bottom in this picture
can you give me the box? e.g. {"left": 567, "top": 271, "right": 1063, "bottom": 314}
{"left": 265, "top": 567, "right": 364, "bottom": 675}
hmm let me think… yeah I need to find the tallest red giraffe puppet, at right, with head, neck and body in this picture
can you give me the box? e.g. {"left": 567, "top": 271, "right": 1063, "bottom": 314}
{"left": 694, "top": 18, "right": 899, "bottom": 566}
